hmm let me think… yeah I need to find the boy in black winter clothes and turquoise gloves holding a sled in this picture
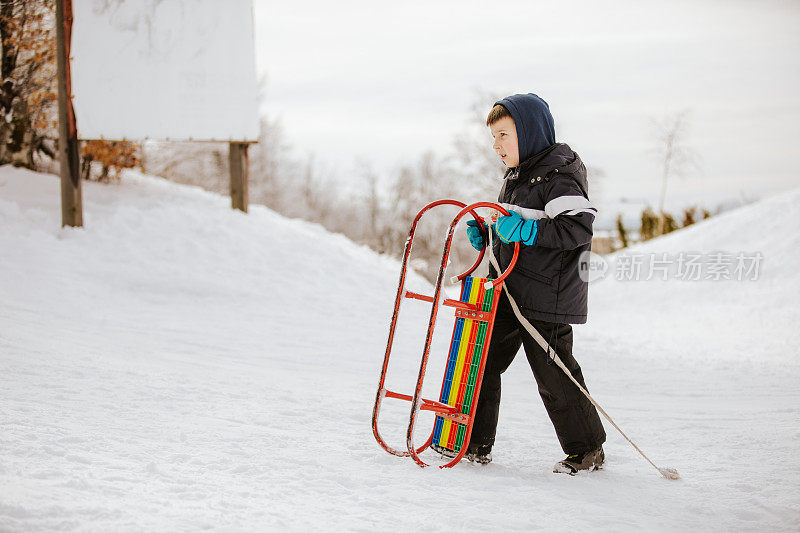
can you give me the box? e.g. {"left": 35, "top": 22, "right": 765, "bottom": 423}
{"left": 466, "top": 94, "right": 606, "bottom": 475}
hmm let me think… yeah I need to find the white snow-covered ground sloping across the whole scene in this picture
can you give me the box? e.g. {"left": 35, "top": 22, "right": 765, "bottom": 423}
{"left": 0, "top": 167, "right": 800, "bottom": 531}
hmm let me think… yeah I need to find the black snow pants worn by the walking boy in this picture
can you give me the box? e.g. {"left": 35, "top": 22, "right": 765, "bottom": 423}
{"left": 470, "top": 292, "right": 606, "bottom": 455}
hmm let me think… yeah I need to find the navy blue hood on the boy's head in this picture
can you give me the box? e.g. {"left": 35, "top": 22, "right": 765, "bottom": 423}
{"left": 494, "top": 93, "right": 556, "bottom": 163}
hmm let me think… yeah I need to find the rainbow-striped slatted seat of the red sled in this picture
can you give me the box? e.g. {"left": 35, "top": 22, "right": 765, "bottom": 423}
{"left": 433, "top": 276, "right": 495, "bottom": 452}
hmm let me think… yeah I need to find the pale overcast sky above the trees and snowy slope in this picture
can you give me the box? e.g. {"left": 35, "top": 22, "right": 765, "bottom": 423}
{"left": 255, "top": 0, "right": 800, "bottom": 212}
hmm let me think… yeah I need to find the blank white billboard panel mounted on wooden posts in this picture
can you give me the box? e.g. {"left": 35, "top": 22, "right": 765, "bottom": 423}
{"left": 71, "top": 0, "right": 259, "bottom": 141}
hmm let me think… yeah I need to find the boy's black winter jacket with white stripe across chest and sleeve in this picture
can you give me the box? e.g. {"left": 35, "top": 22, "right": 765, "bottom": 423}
{"left": 494, "top": 143, "right": 597, "bottom": 324}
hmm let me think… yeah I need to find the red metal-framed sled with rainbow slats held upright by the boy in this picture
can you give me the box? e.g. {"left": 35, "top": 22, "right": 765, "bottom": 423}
{"left": 372, "top": 200, "right": 519, "bottom": 468}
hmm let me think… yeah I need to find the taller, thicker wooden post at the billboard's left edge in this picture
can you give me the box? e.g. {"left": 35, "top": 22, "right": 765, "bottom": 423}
{"left": 56, "top": 0, "right": 83, "bottom": 227}
